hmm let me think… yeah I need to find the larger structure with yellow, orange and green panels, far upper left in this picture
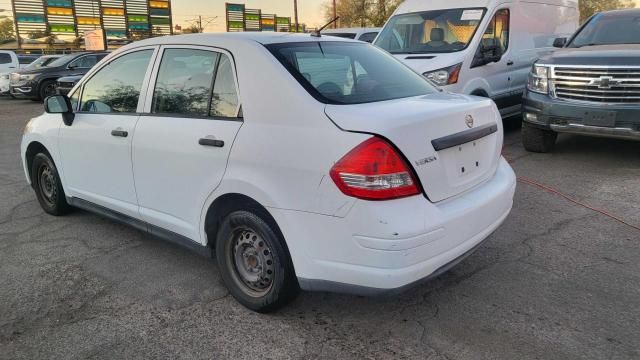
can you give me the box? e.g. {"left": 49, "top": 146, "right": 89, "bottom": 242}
{"left": 12, "top": 0, "right": 173, "bottom": 47}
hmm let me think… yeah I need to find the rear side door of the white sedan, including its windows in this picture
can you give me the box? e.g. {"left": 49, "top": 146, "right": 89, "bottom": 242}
{"left": 133, "top": 46, "right": 242, "bottom": 241}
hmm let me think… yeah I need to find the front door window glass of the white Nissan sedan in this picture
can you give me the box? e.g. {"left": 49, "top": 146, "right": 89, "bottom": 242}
{"left": 80, "top": 49, "right": 153, "bottom": 113}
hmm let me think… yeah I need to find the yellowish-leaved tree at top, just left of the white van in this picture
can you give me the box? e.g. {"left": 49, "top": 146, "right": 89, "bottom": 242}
{"left": 324, "top": 0, "right": 402, "bottom": 27}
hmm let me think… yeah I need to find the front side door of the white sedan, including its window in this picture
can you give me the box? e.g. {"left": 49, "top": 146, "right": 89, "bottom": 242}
{"left": 59, "top": 47, "right": 157, "bottom": 218}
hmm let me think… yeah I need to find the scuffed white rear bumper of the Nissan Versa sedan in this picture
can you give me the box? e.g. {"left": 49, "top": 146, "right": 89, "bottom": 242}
{"left": 270, "top": 160, "right": 516, "bottom": 295}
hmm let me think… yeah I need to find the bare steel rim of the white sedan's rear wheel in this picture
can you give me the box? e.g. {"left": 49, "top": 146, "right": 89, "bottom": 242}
{"left": 228, "top": 228, "right": 275, "bottom": 297}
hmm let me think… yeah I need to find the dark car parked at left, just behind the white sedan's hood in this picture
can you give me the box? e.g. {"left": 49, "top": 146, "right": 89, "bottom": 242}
{"left": 10, "top": 52, "right": 107, "bottom": 100}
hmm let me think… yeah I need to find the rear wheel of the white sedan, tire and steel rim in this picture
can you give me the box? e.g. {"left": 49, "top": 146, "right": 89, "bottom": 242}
{"left": 215, "top": 210, "right": 300, "bottom": 313}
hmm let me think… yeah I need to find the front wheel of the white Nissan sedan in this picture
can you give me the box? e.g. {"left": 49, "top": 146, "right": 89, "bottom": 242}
{"left": 31, "top": 153, "right": 71, "bottom": 216}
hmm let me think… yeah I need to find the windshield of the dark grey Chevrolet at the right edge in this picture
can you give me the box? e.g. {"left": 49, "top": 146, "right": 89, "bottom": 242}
{"left": 569, "top": 11, "right": 640, "bottom": 48}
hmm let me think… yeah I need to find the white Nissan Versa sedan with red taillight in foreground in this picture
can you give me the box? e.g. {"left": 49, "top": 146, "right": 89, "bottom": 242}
{"left": 21, "top": 33, "right": 515, "bottom": 312}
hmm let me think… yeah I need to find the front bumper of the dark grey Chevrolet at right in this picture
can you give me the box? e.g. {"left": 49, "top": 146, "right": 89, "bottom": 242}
{"left": 523, "top": 91, "right": 640, "bottom": 140}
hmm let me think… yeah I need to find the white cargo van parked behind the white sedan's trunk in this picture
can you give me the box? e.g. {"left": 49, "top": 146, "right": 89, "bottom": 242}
{"left": 374, "top": 0, "right": 580, "bottom": 117}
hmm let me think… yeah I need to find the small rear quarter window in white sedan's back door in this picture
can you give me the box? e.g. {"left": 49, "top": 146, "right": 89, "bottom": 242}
{"left": 210, "top": 54, "right": 238, "bottom": 117}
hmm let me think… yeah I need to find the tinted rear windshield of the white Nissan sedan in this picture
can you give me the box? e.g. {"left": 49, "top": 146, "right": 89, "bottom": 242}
{"left": 267, "top": 41, "right": 437, "bottom": 104}
